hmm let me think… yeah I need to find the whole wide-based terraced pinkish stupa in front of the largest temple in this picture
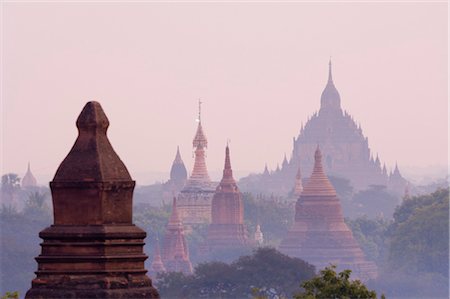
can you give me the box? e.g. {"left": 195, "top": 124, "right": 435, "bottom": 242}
{"left": 279, "top": 146, "right": 377, "bottom": 280}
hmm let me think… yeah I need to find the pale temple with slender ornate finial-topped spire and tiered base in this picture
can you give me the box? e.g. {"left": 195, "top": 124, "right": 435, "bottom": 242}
{"left": 178, "top": 101, "right": 216, "bottom": 226}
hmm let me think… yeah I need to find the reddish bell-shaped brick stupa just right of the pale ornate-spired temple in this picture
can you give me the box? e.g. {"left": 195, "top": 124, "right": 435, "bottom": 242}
{"left": 205, "top": 145, "right": 254, "bottom": 252}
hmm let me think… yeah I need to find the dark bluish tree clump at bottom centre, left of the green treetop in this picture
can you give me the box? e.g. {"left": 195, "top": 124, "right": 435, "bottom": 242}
{"left": 156, "top": 247, "right": 314, "bottom": 298}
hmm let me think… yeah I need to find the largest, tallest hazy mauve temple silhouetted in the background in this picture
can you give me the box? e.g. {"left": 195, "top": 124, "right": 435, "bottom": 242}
{"left": 240, "top": 61, "right": 406, "bottom": 194}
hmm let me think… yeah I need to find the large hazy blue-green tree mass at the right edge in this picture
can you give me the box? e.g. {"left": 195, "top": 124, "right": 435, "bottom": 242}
{"left": 389, "top": 188, "right": 449, "bottom": 278}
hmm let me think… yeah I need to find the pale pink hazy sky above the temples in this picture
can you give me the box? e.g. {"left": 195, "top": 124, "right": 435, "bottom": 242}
{"left": 1, "top": 2, "right": 448, "bottom": 184}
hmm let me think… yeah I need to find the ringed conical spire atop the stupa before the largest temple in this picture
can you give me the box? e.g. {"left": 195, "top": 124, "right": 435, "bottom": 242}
{"left": 302, "top": 145, "right": 336, "bottom": 196}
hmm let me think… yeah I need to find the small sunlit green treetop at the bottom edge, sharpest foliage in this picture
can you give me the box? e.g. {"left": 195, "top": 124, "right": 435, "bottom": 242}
{"left": 294, "top": 265, "right": 384, "bottom": 299}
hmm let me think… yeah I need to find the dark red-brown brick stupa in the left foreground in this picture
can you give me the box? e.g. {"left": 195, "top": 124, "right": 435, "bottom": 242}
{"left": 25, "top": 102, "right": 159, "bottom": 299}
